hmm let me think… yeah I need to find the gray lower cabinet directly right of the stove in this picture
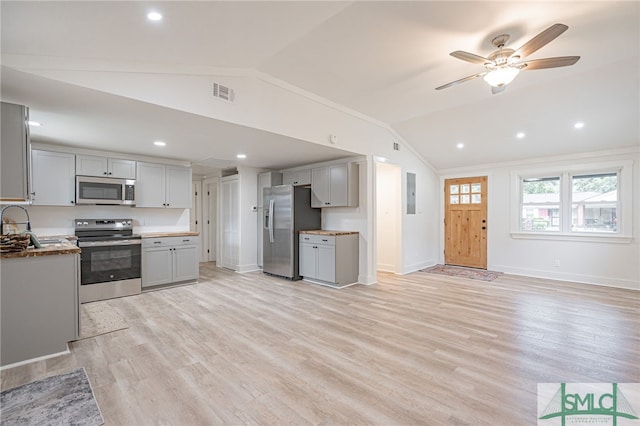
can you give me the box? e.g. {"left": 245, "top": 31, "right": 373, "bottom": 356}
{"left": 142, "top": 236, "right": 200, "bottom": 289}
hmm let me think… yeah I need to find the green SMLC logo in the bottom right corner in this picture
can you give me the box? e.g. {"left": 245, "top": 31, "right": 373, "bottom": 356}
{"left": 538, "top": 383, "right": 638, "bottom": 426}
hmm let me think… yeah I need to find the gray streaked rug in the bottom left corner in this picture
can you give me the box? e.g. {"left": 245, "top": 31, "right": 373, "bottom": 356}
{"left": 0, "top": 368, "right": 104, "bottom": 426}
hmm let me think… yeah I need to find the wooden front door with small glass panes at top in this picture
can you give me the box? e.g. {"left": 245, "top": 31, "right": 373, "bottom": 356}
{"left": 444, "top": 176, "right": 487, "bottom": 269}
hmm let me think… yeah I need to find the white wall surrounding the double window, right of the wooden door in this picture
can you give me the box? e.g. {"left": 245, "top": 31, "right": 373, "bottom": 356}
{"left": 440, "top": 148, "right": 640, "bottom": 290}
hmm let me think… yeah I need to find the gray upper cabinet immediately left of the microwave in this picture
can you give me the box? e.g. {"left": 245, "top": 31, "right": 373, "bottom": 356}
{"left": 31, "top": 149, "right": 76, "bottom": 206}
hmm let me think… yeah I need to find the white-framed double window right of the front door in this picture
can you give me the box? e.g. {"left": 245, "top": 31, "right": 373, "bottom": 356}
{"left": 512, "top": 161, "right": 633, "bottom": 238}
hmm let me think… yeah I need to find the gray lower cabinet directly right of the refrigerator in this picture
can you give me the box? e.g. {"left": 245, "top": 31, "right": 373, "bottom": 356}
{"left": 299, "top": 233, "right": 359, "bottom": 287}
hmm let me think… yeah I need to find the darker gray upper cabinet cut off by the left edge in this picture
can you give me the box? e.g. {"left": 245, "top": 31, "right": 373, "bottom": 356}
{"left": 0, "top": 102, "right": 29, "bottom": 202}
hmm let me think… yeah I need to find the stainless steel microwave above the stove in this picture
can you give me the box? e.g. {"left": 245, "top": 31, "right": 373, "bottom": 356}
{"left": 76, "top": 176, "right": 136, "bottom": 206}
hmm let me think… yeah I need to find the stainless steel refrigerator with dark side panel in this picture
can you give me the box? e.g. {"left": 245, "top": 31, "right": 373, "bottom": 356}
{"left": 262, "top": 185, "right": 321, "bottom": 280}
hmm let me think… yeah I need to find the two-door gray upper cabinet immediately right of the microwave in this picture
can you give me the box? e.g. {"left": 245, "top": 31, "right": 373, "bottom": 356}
{"left": 136, "top": 161, "right": 191, "bottom": 209}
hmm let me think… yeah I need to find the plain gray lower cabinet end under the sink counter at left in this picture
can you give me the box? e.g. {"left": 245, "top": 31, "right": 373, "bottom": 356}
{"left": 0, "top": 254, "right": 80, "bottom": 366}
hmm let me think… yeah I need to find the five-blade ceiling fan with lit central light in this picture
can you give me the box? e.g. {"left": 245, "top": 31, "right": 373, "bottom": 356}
{"left": 436, "top": 24, "right": 580, "bottom": 94}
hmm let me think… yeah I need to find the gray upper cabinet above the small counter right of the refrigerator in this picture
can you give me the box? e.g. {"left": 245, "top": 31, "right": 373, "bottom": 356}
{"left": 311, "top": 163, "right": 358, "bottom": 207}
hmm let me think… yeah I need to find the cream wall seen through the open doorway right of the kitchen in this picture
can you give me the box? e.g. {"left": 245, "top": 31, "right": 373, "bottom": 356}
{"left": 376, "top": 162, "right": 403, "bottom": 272}
